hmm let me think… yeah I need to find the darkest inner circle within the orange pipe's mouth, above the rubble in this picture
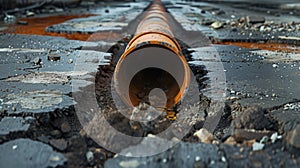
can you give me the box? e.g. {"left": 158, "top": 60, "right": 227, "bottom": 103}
{"left": 128, "top": 68, "right": 180, "bottom": 108}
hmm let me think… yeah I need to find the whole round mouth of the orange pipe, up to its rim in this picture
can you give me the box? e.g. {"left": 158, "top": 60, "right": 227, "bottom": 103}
{"left": 114, "top": 45, "right": 187, "bottom": 110}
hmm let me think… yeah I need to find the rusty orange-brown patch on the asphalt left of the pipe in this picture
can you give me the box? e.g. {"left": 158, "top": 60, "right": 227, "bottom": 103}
{"left": 3, "top": 14, "right": 121, "bottom": 41}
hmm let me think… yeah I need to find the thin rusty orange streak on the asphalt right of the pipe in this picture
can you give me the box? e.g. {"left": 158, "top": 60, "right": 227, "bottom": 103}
{"left": 215, "top": 42, "right": 300, "bottom": 53}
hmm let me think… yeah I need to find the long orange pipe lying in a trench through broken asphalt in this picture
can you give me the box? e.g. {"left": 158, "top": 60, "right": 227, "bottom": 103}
{"left": 113, "top": 0, "right": 190, "bottom": 119}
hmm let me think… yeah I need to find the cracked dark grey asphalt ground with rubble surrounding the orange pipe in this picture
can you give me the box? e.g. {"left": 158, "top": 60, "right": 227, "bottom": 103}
{"left": 0, "top": 0, "right": 300, "bottom": 168}
